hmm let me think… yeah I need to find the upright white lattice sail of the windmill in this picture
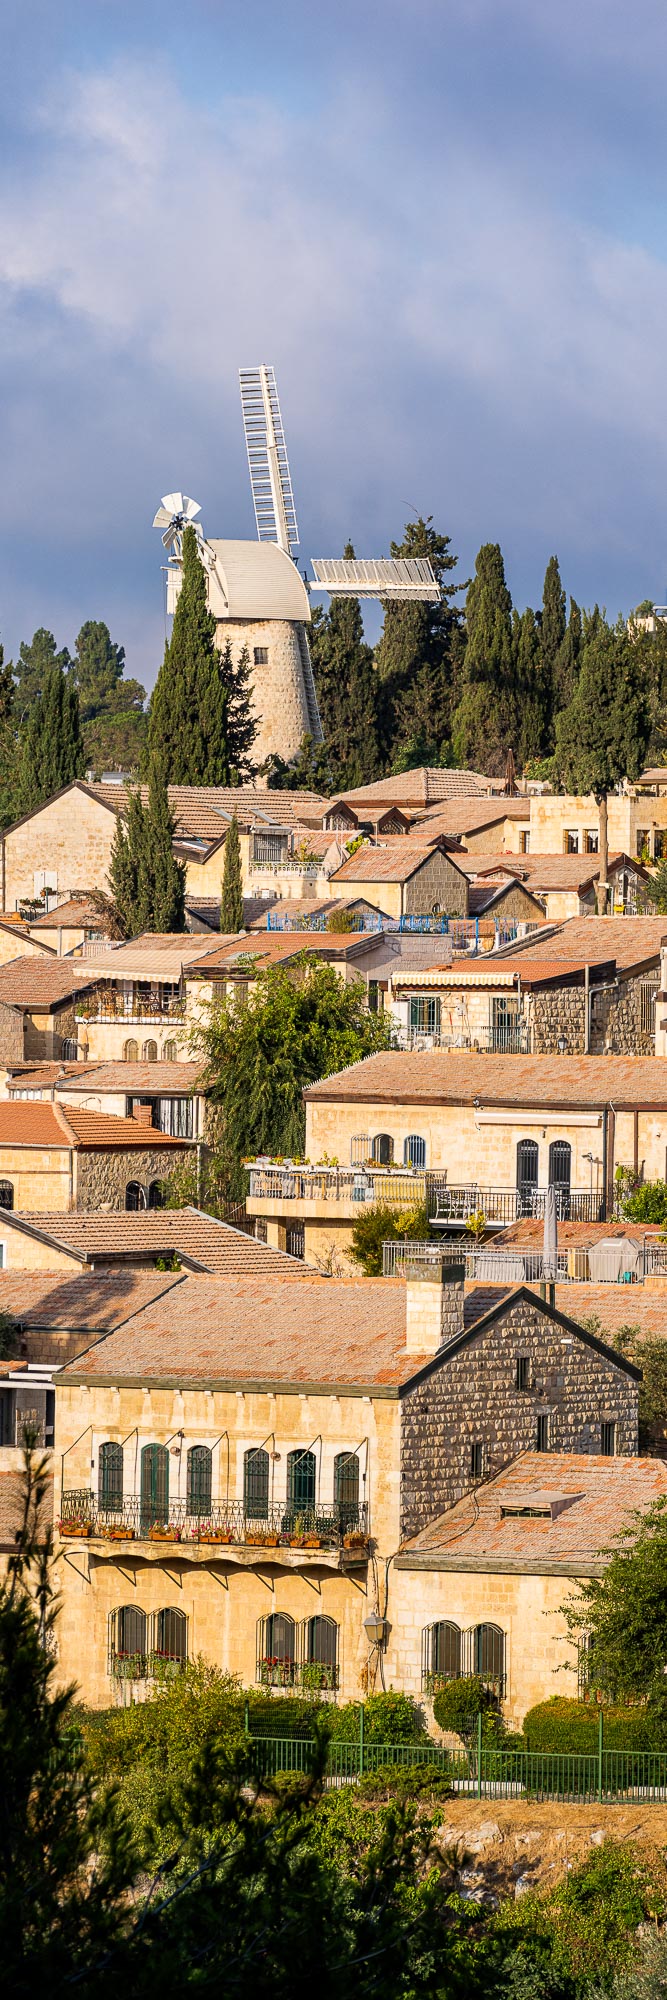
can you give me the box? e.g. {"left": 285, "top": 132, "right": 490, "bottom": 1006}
{"left": 240, "top": 362, "right": 300, "bottom": 556}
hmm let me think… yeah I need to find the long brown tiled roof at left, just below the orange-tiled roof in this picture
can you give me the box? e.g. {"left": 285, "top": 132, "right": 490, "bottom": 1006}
{"left": 2, "top": 1208, "right": 311, "bottom": 1282}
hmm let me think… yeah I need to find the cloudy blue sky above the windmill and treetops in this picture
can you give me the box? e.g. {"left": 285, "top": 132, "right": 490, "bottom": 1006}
{"left": 0, "top": 0, "right": 667, "bottom": 688}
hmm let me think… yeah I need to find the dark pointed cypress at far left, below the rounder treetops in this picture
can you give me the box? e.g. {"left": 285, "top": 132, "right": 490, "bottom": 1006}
{"left": 16, "top": 666, "right": 86, "bottom": 814}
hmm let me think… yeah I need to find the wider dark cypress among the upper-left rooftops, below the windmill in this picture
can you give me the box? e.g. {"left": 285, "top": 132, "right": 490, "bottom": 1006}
{"left": 110, "top": 758, "right": 186, "bottom": 938}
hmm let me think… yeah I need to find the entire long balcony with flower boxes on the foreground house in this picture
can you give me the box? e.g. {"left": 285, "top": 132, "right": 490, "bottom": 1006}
{"left": 58, "top": 1488, "right": 369, "bottom": 1568}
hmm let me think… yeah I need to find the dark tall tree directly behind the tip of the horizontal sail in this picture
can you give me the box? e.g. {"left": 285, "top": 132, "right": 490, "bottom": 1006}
{"left": 375, "top": 516, "right": 459, "bottom": 768}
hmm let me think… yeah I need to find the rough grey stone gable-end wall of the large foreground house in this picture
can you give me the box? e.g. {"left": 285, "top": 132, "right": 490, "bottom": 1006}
{"left": 401, "top": 1298, "right": 639, "bottom": 1540}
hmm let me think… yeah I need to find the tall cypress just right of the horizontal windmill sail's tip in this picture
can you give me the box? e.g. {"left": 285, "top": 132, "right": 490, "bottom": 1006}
{"left": 453, "top": 542, "right": 521, "bottom": 778}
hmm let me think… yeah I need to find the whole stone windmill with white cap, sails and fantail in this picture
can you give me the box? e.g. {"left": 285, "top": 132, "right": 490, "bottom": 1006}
{"left": 154, "top": 362, "right": 439, "bottom": 764}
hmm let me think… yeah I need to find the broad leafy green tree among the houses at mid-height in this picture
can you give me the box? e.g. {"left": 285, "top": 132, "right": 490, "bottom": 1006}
{"left": 194, "top": 960, "right": 389, "bottom": 1194}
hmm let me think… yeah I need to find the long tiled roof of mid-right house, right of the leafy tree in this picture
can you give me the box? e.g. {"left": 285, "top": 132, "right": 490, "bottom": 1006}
{"left": 304, "top": 1048, "right": 667, "bottom": 1110}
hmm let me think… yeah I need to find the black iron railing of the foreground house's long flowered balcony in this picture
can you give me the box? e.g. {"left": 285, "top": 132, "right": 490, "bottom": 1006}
{"left": 60, "top": 1488, "right": 369, "bottom": 1550}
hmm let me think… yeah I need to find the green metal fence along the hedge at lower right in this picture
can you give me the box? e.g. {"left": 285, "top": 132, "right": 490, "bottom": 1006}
{"left": 250, "top": 1710, "right": 667, "bottom": 1804}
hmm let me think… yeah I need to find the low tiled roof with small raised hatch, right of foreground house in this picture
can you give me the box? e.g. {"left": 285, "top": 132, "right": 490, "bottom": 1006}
{"left": 397, "top": 1452, "right": 667, "bottom": 1574}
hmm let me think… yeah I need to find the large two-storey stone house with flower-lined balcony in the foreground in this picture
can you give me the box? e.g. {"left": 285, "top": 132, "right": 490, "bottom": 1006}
{"left": 50, "top": 1272, "right": 639, "bottom": 1710}
